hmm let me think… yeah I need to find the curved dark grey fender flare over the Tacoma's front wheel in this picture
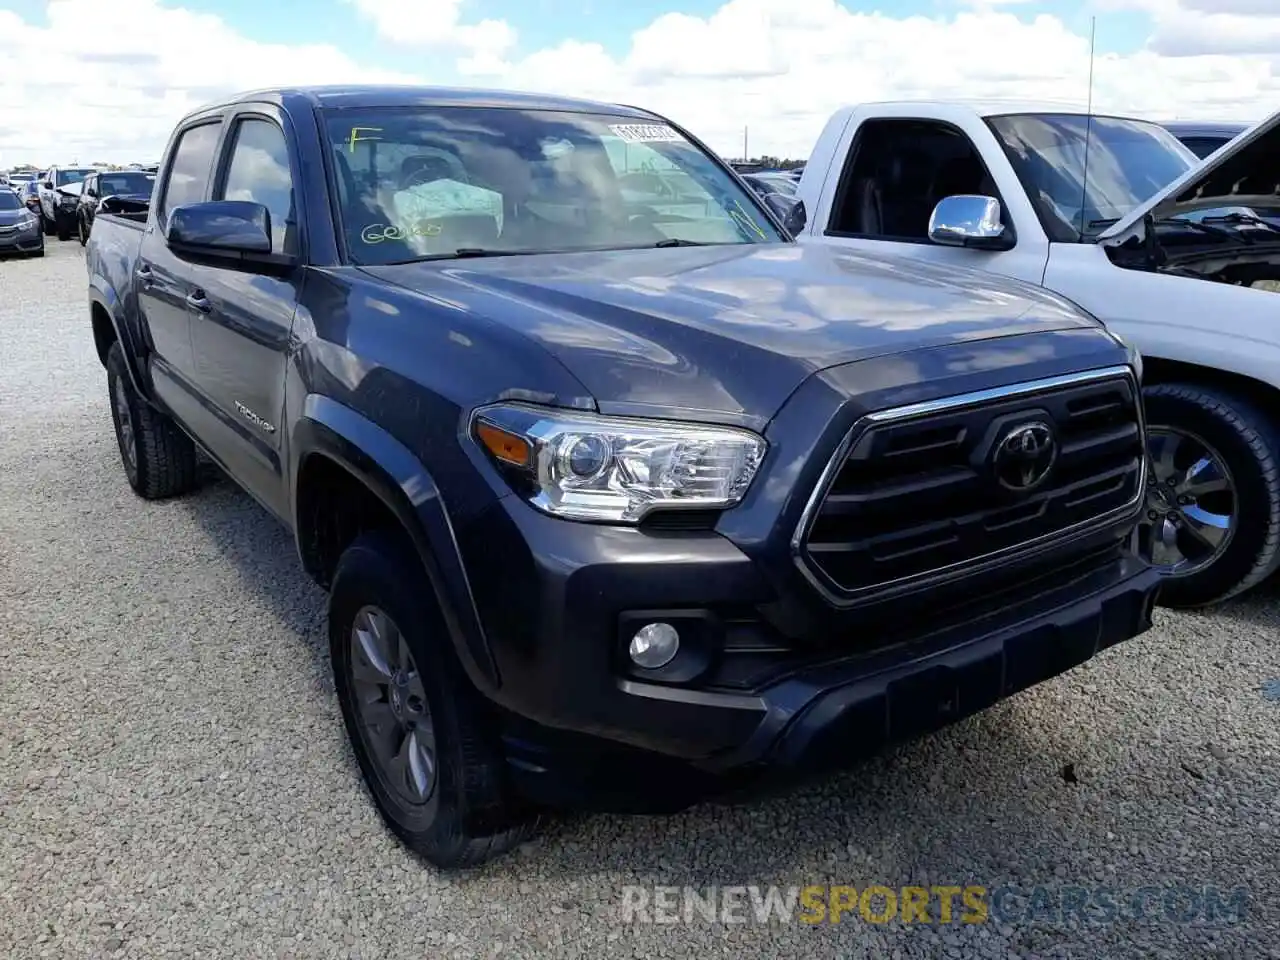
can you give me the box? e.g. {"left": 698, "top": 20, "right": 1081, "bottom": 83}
{"left": 291, "top": 394, "right": 500, "bottom": 694}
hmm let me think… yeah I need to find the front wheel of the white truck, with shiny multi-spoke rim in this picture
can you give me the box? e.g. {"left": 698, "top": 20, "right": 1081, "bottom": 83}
{"left": 1140, "top": 383, "right": 1280, "bottom": 607}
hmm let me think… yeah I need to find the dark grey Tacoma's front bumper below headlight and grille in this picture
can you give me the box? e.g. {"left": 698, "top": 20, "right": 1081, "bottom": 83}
{"left": 462, "top": 488, "right": 1160, "bottom": 810}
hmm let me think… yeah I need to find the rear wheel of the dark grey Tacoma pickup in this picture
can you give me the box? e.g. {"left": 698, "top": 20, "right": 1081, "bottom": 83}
{"left": 106, "top": 342, "right": 197, "bottom": 500}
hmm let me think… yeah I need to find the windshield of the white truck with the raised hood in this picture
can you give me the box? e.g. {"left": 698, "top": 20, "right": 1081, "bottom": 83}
{"left": 987, "top": 114, "right": 1199, "bottom": 242}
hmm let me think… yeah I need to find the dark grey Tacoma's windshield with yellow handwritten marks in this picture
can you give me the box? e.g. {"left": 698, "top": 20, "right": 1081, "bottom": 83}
{"left": 325, "top": 106, "right": 783, "bottom": 264}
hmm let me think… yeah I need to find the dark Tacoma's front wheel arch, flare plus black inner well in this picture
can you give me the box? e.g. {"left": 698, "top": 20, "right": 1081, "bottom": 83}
{"left": 292, "top": 394, "right": 500, "bottom": 692}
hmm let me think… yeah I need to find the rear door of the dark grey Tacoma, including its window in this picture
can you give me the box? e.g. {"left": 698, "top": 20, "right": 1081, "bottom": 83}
{"left": 133, "top": 116, "right": 223, "bottom": 435}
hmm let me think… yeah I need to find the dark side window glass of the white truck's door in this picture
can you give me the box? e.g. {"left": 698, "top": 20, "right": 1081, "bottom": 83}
{"left": 827, "top": 119, "right": 997, "bottom": 243}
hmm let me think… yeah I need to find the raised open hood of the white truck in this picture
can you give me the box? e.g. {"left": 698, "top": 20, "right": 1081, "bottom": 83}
{"left": 1098, "top": 110, "right": 1280, "bottom": 241}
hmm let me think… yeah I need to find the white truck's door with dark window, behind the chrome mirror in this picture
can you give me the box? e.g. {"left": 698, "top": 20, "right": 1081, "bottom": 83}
{"left": 801, "top": 116, "right": 1048, "bottom": 284}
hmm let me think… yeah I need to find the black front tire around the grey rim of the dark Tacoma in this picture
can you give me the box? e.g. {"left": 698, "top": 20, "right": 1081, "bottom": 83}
{"left": 329, "top": 531, "right": 538, "bottom": 869}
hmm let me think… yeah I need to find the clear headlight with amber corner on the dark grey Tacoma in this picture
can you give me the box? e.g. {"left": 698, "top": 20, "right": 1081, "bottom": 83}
{"left": 472, "top": 403, "right": 767, "bottom": 524}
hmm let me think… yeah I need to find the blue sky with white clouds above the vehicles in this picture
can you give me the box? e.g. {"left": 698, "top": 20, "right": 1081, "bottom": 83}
{"left": 0, "top": 0, "right": 1280, "bottom": 166}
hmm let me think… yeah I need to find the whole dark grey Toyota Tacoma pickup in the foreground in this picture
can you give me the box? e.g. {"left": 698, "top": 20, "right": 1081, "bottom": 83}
{"left": 86, "top": 87, "right": 1160, "bottom": 867}
